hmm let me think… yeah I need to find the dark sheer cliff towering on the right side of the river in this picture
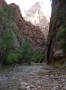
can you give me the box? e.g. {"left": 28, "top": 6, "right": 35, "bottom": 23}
{"left": 47, "top": 0, "right": 66, "bottom": 63}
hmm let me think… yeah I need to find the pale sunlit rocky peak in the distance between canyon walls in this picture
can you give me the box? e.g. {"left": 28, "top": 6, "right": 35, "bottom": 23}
{"left": 23, "top": 1, "right": 50, "bottom": 30}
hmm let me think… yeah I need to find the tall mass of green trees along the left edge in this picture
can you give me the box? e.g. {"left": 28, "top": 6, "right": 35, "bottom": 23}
{"left": 0, "top": 5, "right": 15, "bottom": 63}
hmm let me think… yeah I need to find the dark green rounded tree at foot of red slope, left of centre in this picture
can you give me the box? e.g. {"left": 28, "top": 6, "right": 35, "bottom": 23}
{"left": 19, "top": 42, "right": 34, "bottom": 63}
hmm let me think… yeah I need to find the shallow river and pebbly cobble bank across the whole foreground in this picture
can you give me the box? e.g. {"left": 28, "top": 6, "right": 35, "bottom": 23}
{"left": 0, "top": 63, "right": 66, "bottom": 90}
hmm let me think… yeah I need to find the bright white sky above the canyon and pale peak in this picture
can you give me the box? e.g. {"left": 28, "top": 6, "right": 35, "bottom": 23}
{"left": 5, "top": 0, "right": 51, "bottom": 14}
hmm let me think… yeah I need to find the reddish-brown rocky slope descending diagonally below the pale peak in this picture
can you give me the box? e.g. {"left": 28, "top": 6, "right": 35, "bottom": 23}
{"left": 11, "top": 3, "right": 45, "bottom": 49}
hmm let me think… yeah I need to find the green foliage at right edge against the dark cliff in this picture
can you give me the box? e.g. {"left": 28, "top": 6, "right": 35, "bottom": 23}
{"left": 57, "top": 28, "right": 66, "bottom": 53}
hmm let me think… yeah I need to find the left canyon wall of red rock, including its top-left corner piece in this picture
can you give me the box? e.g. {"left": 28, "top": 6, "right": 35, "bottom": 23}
{"left": 0, "top": 0, "right": 47, "bottom": 50}
